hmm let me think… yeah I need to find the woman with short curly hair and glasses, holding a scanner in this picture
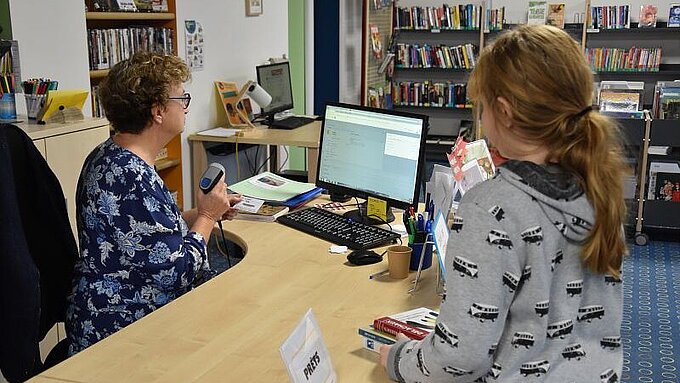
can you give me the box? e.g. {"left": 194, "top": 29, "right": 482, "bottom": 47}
{"left": 66, "top": 52, "right": 240, "bottom": 355}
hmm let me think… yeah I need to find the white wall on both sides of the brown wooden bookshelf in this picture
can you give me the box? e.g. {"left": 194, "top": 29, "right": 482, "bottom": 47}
{"left": 10, "top": 0, "right": 288, "bottom": 208}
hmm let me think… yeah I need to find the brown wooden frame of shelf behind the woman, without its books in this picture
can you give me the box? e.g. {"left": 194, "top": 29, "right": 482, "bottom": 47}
{"left": 85, "top": 0, "right": 184, "bottom": 209}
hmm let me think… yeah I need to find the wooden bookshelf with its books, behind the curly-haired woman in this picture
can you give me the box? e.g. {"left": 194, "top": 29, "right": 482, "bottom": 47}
{"left": 85, "top": 0, "right": 184, "bottom": 208}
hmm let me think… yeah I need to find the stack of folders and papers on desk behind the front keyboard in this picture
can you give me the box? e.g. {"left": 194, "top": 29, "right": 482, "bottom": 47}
{"left": 229, "top": 172, "right": 322, "bottom": 214}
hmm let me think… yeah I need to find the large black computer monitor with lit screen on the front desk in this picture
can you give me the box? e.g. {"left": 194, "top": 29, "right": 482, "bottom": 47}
{"left": 316, "top": 103, "right": 428, "bottom": 224}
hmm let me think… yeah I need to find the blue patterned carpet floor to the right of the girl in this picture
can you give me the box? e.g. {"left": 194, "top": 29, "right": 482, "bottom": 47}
{"left": 621, "top": 241, "right": 680, "bottom": 383}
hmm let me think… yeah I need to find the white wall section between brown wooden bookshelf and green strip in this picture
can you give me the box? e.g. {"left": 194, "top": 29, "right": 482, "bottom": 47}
{"left": 177, "top": 0, "right": 288, "bottom": 208}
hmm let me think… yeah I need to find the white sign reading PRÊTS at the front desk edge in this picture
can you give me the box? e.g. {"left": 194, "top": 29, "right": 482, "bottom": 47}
{"left": 279, "top": 308, "right": 337, "bottom": 383}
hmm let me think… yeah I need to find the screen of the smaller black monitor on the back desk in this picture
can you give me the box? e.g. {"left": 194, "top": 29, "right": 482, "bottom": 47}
{"left": 255, "top": 61, "right": 293, "bottom": 115}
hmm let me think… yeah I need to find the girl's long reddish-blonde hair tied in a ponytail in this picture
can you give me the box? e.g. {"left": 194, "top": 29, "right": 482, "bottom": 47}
{"left": 468, "top": 25, "right": 629, "bottom": 277}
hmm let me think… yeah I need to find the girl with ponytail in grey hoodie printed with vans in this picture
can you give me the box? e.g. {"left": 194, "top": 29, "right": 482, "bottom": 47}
{"left": 381, "top": 25, "right": 629, "bottom": 382}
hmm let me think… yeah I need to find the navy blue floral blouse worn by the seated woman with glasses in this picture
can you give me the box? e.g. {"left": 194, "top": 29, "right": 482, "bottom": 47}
{"left": 66, "top": 139, "right": 210, "bottom": 355}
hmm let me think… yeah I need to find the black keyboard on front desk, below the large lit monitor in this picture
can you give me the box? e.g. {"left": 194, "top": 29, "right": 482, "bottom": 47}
{"left": 276, "top": 207, "right": 399, "bottom": 250}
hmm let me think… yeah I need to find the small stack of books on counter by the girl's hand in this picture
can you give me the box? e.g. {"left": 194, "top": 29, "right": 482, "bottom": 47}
{"left": 359, "top": 307, "right": 439, "bottom": 352}
